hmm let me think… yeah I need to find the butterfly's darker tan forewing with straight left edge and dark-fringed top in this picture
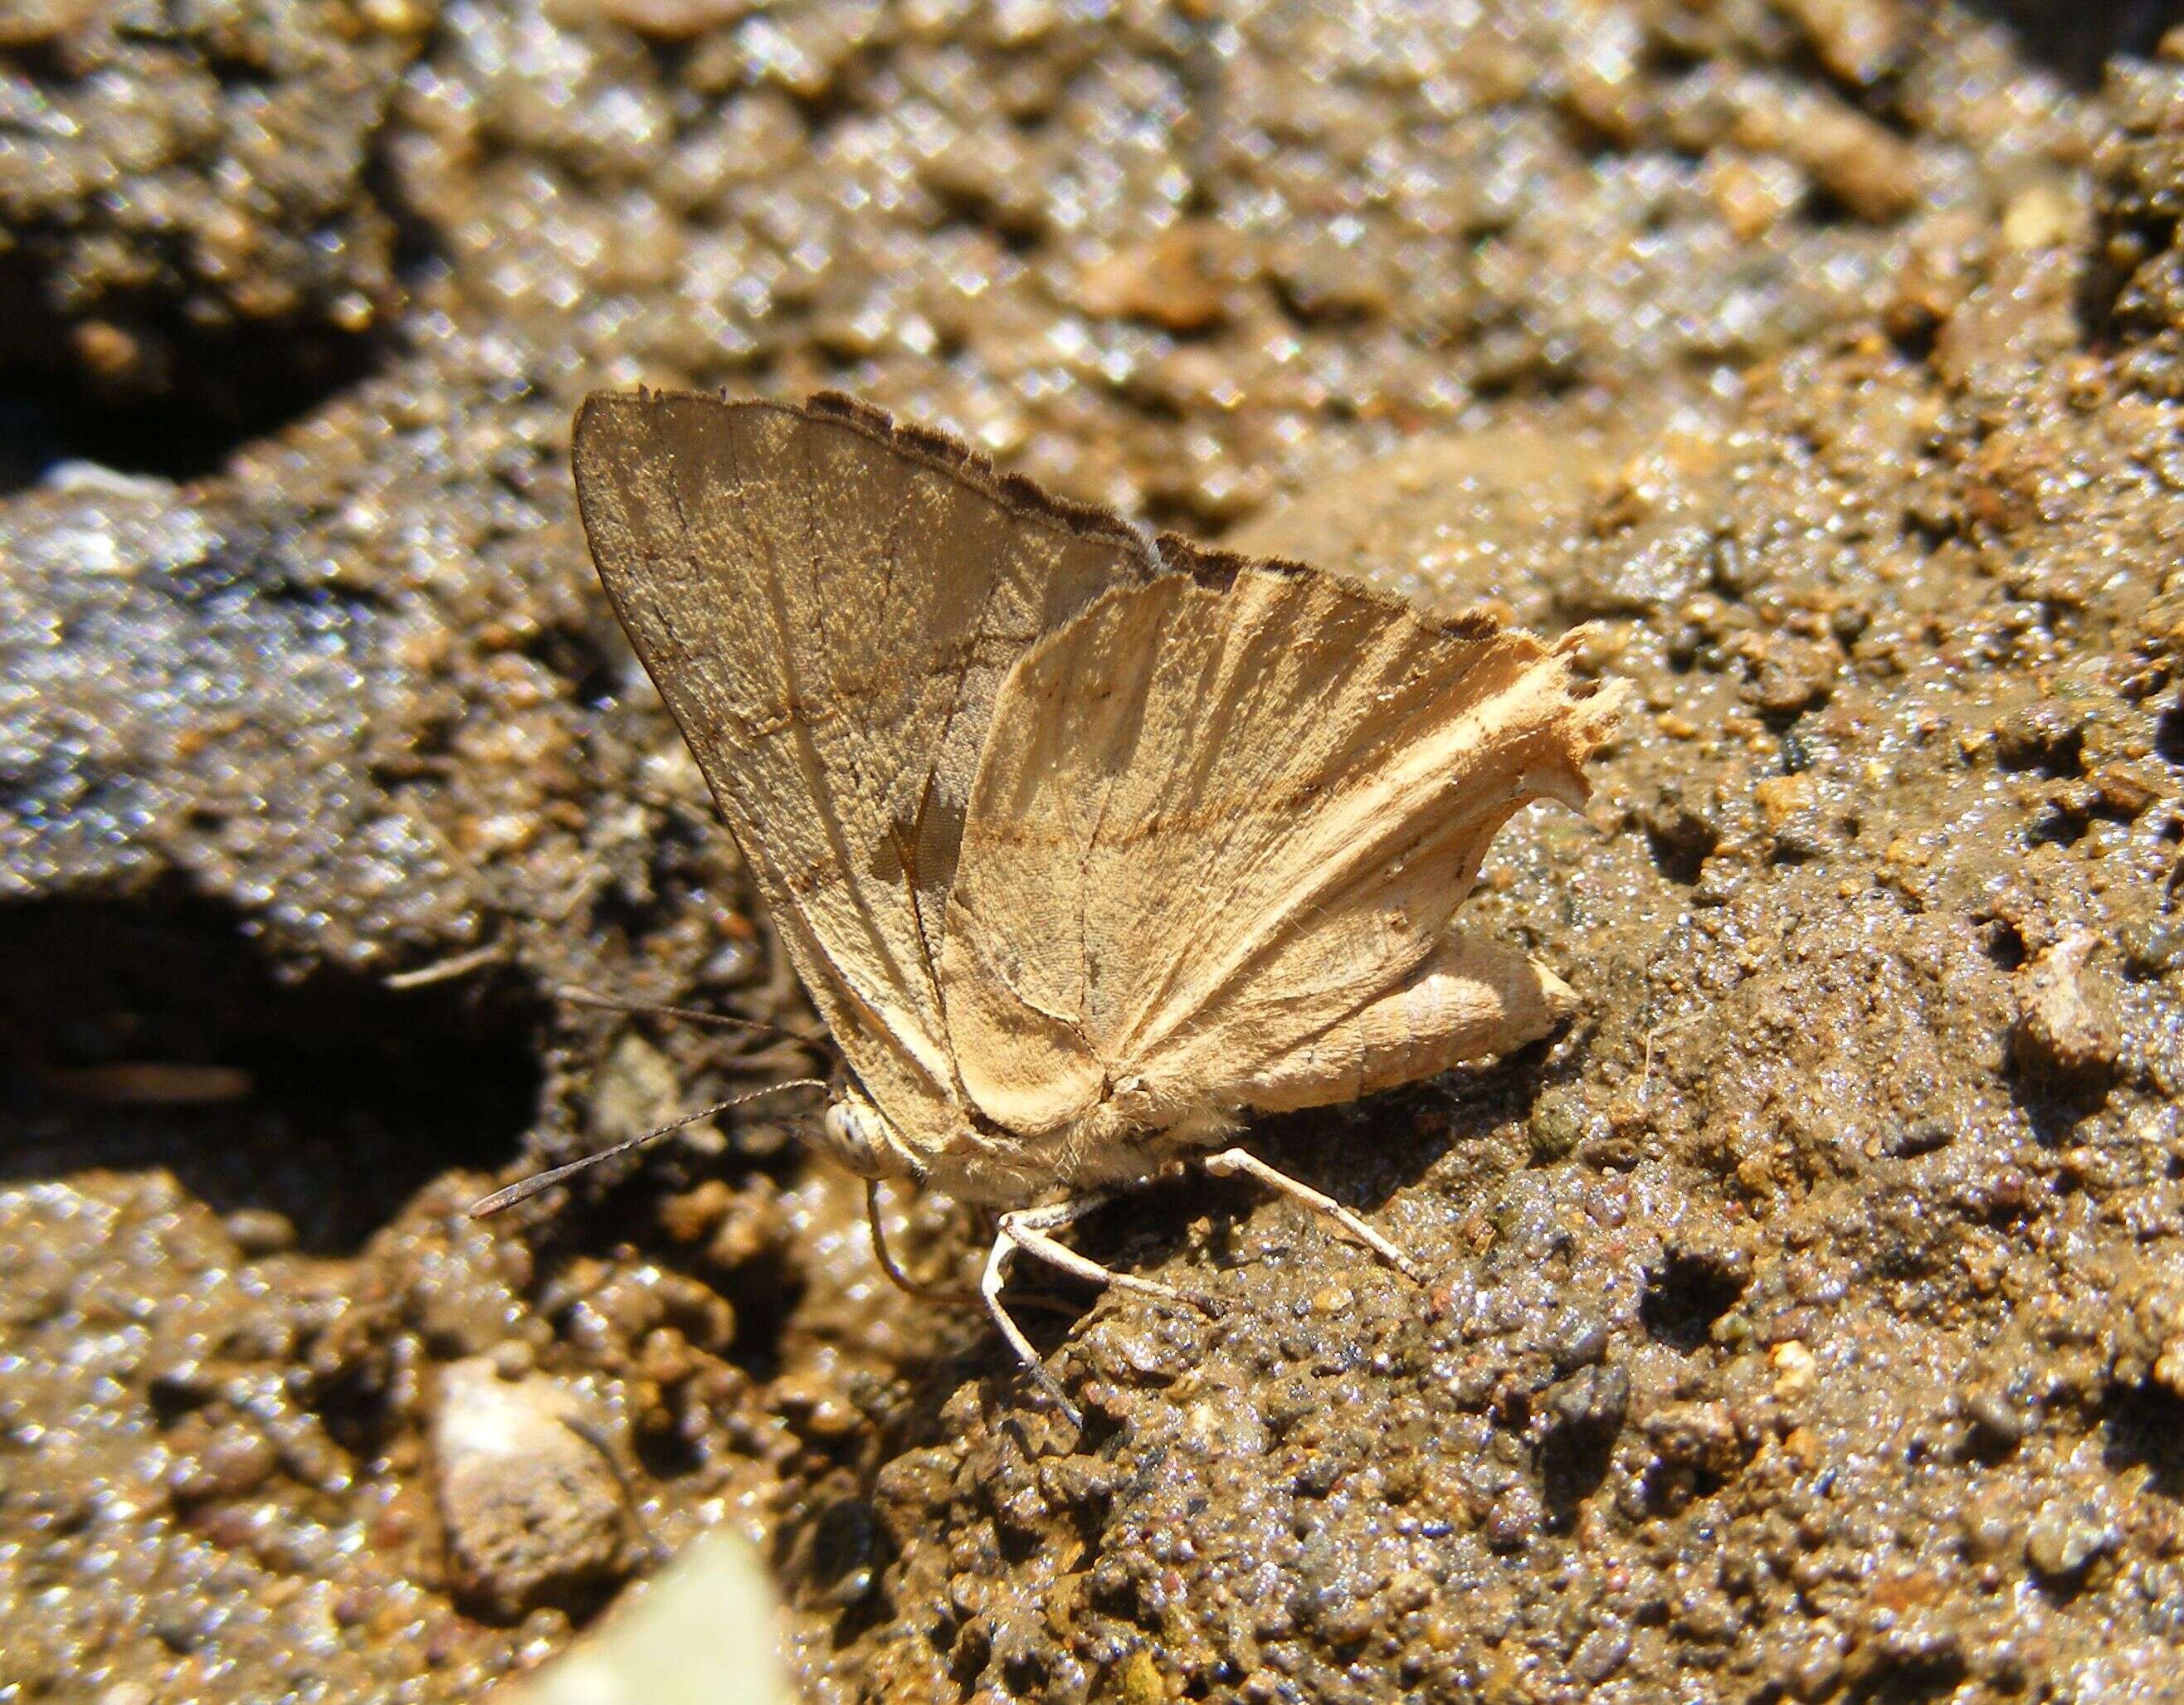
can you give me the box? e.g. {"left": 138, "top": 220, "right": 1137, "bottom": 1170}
{"left": 574, "top": 393, "right": 1158, "bottom": 1146}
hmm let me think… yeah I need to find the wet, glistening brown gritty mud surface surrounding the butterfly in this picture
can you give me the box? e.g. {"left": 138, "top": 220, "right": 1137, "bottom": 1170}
{"left": 0, "top": 0, "right": 2184, "bottom": 1705}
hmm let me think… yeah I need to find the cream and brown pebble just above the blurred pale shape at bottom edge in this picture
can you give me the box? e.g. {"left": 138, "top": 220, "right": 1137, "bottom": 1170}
{"left": 432, "top": 1356, "right": 626, "bottom": 1622}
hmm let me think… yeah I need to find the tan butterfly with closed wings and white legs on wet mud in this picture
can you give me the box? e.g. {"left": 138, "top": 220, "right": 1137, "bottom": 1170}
{"left": 546, "top": 391, "right": 1616, "bottom": 1408}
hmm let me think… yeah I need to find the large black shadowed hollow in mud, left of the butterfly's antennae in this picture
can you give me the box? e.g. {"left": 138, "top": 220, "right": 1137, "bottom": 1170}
{"left": 0, "top": 891, "right": 544, "bottom": 1253}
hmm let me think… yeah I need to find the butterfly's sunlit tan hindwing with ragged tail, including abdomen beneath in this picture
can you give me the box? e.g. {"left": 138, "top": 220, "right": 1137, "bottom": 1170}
{"left": 941, "top": 552, "right": 1614, "bottom": 1135}
